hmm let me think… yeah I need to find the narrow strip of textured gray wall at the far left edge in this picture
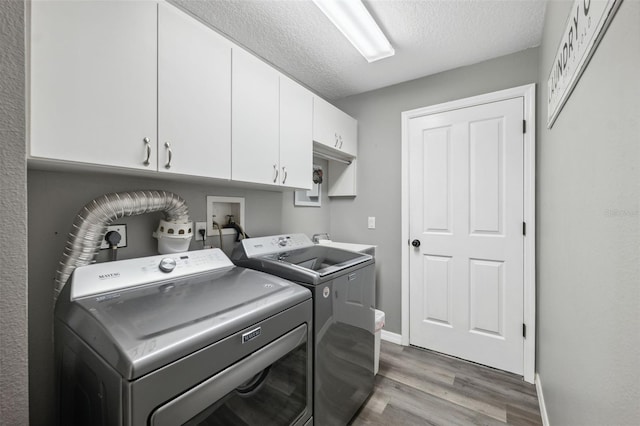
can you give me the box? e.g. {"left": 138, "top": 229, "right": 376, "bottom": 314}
{"left": 0, "top": 1, "right": 29, "bottom": 426}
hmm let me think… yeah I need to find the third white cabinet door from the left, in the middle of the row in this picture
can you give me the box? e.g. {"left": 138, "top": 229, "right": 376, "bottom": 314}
{"left": 231, "top": 48, "right": 280, "bottom": 185}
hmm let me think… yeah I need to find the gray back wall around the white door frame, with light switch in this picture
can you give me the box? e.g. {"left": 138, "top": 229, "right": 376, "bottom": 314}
{"left": 330, "top": 49, "right": 538, "bottom": 333}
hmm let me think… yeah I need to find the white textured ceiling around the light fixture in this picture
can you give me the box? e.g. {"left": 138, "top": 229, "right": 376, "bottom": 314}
{"left": 171, "top": 0, "right": 546, "bottom": 100}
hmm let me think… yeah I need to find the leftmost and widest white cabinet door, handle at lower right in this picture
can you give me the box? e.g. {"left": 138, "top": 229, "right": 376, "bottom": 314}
{"left": 30, "top": 0, "right": 157, "bottom": 170}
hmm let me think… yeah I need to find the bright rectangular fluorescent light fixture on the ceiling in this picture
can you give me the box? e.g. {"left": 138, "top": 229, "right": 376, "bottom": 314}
{"left": 313, "top": 0, "right": 396, "bottom": 62}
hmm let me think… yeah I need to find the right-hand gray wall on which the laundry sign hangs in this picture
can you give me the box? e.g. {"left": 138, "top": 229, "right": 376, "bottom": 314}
{"left": 537, "top": 0, "right": 640, "bottom": 425}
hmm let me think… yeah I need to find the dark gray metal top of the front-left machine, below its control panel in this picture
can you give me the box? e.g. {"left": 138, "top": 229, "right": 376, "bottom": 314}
{"left": 56, "top": 266, "right": 311, "bottom": 380}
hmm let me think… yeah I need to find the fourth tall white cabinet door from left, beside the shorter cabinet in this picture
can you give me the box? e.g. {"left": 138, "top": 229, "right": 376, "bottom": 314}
{"left": 279, "top": 75, "right": 313, "bottom": 189}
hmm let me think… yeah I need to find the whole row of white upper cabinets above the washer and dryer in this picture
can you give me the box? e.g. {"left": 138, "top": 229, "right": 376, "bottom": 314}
{"left": 29, "top": 0, "right": 324, "bottom": 189}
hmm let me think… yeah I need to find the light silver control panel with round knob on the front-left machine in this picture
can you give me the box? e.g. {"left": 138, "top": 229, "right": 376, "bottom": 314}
{"left": 67, "top": 249, "right": 233, "bottom": 300}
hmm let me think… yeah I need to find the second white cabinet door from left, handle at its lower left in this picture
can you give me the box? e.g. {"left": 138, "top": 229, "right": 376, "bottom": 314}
{"left": 158, "top": 3, "right": 231, "bottom": 179}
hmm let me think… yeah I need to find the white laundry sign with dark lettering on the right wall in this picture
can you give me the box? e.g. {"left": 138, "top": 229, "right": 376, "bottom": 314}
{"left": 547, "top": 0, "right": 622, "bottom": 128}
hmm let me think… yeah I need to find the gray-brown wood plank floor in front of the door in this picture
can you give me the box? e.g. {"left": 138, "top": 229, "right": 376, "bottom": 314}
{"left": 351, "top": 341, "right": 542, "bottom": 426}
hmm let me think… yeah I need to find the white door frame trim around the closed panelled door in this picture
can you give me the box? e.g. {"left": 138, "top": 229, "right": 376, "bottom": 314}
{"left": 401, "top": 84, "right": 536, "bottom": 383}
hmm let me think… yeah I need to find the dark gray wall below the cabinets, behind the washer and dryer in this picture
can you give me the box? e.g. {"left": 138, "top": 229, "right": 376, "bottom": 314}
{"left": 26, "top": 170, "right": 326, "bottom": 425}
